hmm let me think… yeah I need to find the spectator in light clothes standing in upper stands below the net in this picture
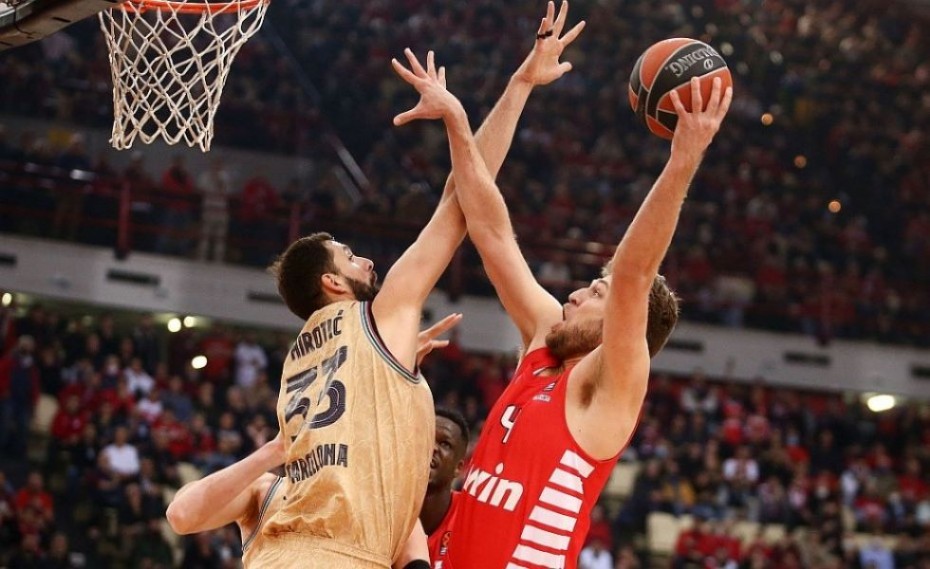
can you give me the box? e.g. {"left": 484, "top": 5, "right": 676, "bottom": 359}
{"left": 197, "top": 158, "right": 232, "bottom": 262}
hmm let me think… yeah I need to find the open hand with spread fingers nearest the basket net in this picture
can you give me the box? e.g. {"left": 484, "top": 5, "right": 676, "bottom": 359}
{"left": 391, "top": 48, "right": 462, "bottom": 126}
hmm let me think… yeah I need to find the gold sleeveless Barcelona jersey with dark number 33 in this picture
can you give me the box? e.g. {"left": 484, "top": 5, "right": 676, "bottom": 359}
{"left": 256, "top": 301, "right": 435, "bottom": 569}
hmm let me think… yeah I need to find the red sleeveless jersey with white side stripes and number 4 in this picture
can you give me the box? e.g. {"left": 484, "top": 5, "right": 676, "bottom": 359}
{"left": 444, "top": 348, "right": 619, "bottom": 569}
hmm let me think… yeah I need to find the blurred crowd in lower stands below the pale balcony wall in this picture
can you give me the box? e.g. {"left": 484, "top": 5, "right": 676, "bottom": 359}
{"left": 0, "top": 305, "right": 930, "bottom": 569}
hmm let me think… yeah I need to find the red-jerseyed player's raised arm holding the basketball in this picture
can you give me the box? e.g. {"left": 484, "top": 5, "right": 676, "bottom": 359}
{"left": 568, "top": 79, "right": 733, "bottom": 458}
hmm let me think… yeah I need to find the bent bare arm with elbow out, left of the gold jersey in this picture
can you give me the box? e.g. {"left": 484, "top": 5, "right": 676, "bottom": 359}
{"left": 166, "top": 435, "right": 284, "bottom": 535}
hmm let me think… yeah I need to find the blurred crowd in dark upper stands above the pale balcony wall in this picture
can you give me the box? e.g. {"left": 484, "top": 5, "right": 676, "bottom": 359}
{"left": 0, "top": 0, "right": 930, "bottom": 346}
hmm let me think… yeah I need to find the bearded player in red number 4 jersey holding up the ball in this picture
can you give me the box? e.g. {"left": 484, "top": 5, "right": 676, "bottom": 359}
{"left": 404, "top": 4, "right": 732, "bottom": 569}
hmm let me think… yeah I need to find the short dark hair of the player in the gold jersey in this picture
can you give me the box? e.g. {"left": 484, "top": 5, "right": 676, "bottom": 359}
{"left": 268, "top": 232, "right": 337, "bottom": 320}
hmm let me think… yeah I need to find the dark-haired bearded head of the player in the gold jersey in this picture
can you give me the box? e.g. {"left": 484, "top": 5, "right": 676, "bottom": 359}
{"left": 269, "top": 233, "right": 378, "bottom": 320}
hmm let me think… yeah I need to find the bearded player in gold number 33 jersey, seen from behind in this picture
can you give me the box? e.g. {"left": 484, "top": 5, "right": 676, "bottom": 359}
{"left": 250, "top": 8, "right": 580, "bottom": 569}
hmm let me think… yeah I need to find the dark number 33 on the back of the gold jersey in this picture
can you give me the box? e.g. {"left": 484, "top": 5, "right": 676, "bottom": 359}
{"left": 284, "top": 346, "right": 349, "bottom": 429}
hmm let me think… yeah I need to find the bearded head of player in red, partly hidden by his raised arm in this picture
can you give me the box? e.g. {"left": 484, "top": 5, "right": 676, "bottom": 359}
{"left": 546, "top": 265, "right": 678, "bottom": 361}
